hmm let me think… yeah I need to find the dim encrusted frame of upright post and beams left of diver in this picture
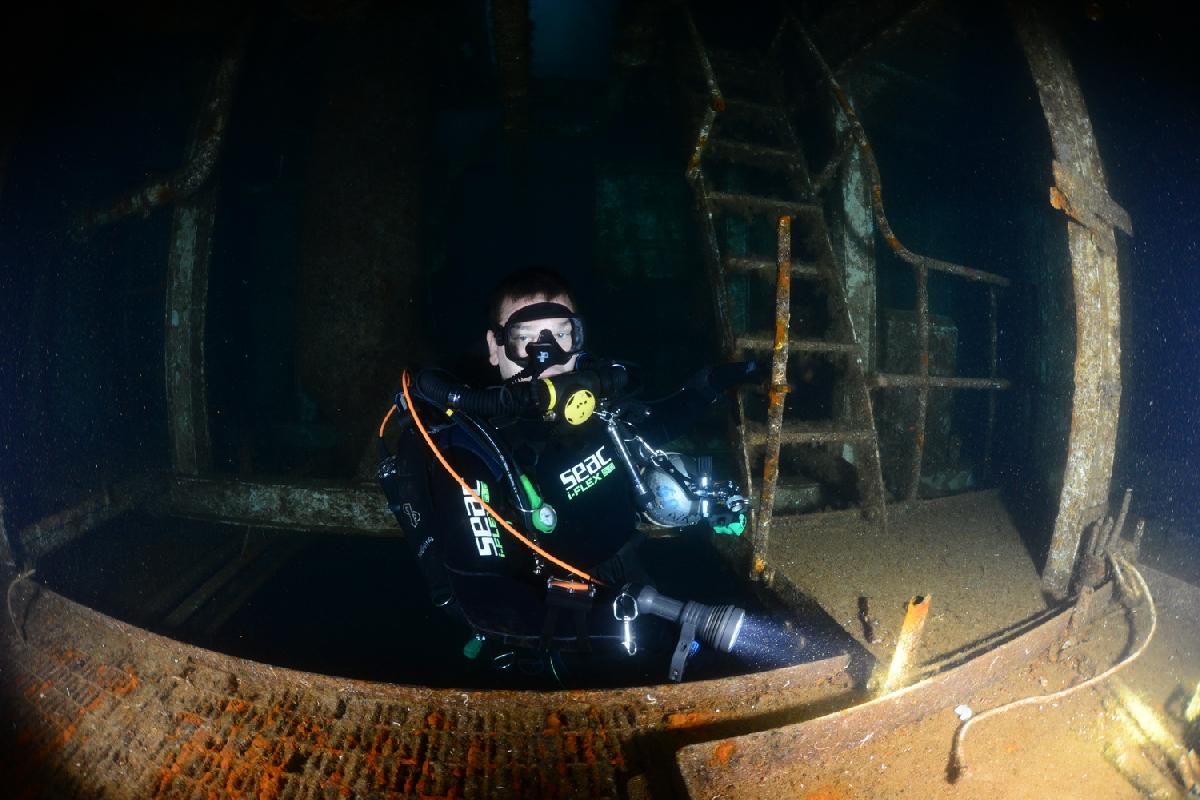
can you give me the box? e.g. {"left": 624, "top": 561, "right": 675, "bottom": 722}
{"left": 12, "top": 23, "right": 422, "bottom": 564}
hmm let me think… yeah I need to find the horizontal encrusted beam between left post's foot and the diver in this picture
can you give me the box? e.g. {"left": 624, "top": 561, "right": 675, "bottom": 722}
{"left": 166, "top": 475, "right": 393, "bottom": 536}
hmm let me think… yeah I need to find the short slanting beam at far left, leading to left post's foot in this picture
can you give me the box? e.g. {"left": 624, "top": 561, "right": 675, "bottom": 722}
{"left": 13, "top": 475, "right": 162, "bottom": 566}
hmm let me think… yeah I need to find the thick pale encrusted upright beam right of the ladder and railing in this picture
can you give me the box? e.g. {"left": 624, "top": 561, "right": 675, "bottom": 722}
{"left": 1012, "top": 4, "right": 1132, "bottom": 597}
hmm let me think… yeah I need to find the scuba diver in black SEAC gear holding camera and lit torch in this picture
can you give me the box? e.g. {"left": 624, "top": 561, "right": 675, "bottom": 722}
{"left": 379, "top": 267, "right": 766, "bottom": 680}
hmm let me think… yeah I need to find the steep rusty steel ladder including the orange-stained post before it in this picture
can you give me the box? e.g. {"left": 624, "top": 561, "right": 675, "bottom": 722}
{"left": 686, "top": 13, "right": 887, "bottom": 578}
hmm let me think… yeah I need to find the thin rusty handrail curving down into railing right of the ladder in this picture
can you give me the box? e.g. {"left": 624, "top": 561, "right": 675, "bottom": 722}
{"left": 788, "top": 14, "right": 1010, "bottom": 500}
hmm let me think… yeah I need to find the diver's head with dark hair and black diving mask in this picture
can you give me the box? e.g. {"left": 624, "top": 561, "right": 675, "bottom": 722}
{"left": 487, "top": 267, "right": 583, "bottom": 380}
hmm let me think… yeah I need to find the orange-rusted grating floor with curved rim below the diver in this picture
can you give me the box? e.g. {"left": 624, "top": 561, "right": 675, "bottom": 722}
{"left": 0, "top": 581, "right": 848, "bottom": 800}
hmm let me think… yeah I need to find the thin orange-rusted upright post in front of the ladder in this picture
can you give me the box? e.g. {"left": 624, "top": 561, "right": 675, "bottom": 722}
{"left": 754, "top": 216, "right": 792, "bottom": 575}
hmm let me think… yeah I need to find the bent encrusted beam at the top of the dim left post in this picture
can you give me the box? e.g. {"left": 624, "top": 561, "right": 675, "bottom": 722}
{"left": 80, "top": 23, "right": 250, "bottom": 233}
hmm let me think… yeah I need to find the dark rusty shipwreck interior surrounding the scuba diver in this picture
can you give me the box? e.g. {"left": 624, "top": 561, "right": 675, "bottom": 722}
{"left": 0, "top": 0, "right": 1200, "bottom": 799}
